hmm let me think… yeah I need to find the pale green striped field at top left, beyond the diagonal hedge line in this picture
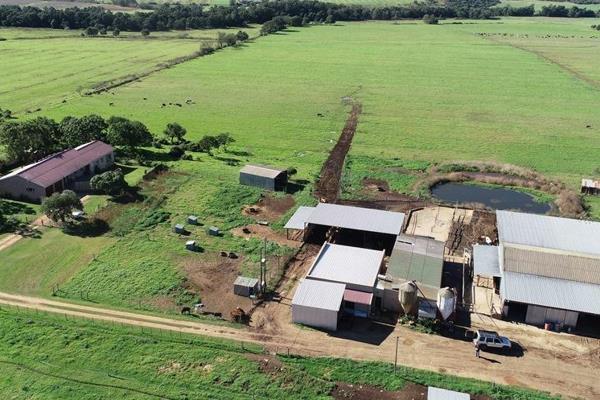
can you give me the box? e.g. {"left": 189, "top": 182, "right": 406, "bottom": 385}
{"left": 0, "top": 28, "right": 256, "bottom": 113}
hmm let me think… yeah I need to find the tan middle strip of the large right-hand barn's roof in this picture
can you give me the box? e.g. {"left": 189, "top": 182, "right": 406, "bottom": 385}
{"left": 503, "top": 245, "right": 600, "bottom": 285}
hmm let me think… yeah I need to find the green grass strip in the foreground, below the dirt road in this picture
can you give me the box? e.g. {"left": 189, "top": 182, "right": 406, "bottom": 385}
{"left": 0, "top": 307, "right": 552, "bottom": 400}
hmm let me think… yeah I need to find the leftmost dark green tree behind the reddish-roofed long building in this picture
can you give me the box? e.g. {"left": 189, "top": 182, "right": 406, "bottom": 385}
{"left": 0, "top": 117, "right": 60, "bottom": 163}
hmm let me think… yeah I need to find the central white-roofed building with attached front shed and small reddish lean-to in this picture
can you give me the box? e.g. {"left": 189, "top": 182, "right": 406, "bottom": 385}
{"left": 292, "top": 243, "right": 398, "bottom": 330}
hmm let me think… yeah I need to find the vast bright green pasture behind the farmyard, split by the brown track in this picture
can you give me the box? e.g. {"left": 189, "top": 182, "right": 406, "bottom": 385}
{"left": 29, "top": 19, "right": 600, "bottom": 189}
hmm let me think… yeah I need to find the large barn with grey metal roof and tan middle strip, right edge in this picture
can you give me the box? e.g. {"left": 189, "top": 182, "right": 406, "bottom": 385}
{"left": 473, "top": 211, "right": 600, "bottom": 331}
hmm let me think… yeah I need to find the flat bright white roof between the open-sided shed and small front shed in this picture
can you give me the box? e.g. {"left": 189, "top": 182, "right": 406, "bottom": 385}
{"left": 307, "top": 243, "right": 385, "bottom": 287}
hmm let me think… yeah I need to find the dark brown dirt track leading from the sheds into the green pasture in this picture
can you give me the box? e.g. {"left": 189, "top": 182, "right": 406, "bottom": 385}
{"left": 315, "top": 102, "right": 362, "bottom": 203}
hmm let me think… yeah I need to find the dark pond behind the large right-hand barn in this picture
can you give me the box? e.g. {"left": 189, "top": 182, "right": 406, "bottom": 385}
{"left": 431, "top": 182, "right": 551, "bottom": 214}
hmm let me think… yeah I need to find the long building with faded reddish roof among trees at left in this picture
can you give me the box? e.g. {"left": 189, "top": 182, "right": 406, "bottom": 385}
{"left": 0, "top": 140, "right": 114, "bottom": 202}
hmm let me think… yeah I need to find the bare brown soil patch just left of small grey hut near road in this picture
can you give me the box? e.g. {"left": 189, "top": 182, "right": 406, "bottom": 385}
{"left": 180, "top": 254, "right": 252, "bottom": 319}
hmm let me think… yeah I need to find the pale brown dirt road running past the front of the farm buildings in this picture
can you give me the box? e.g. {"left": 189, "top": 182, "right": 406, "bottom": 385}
{"left": 0, "top": 293, "right": 600, "bottom": 399}
